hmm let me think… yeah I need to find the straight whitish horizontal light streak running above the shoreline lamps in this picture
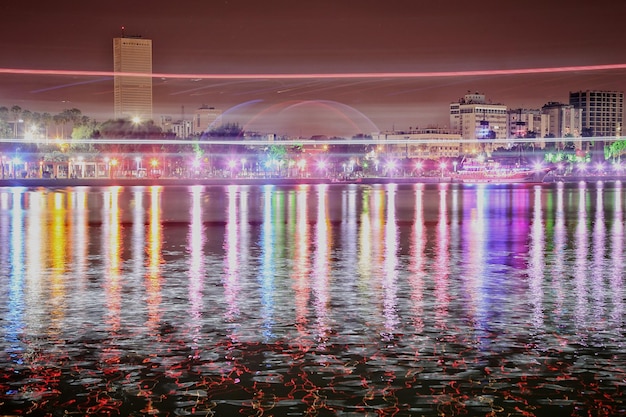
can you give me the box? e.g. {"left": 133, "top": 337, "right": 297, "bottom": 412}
{"left": 0, "top": 136, "right": 626, "bottom": 146}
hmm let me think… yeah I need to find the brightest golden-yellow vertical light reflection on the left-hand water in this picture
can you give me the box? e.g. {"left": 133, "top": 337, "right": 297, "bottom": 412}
{"left": 49, "top": 192, "right": 68, "bottom": 335}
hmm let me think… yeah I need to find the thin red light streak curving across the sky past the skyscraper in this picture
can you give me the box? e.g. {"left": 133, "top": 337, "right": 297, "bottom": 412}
{"left": 0, "top": 64, "right": 626, "bottom": 80}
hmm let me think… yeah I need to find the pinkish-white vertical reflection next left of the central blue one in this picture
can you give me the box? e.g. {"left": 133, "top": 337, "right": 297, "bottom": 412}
{"left": 224, "top": 185, "right": 239, "bottom": 322}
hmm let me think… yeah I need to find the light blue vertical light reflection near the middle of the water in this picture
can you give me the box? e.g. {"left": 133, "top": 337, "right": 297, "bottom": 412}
{"left": 260, "top": 185, "right": 276, "bottom": 340}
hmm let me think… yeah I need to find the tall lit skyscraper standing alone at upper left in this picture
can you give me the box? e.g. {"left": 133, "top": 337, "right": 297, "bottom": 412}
{"left": 113, "top": 36, "right": 152, "bottom": 121}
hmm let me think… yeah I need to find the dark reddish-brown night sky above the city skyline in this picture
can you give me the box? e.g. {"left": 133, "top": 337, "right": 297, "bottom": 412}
{"left": 0, "top": 0, "right": 626, "bottom": 134}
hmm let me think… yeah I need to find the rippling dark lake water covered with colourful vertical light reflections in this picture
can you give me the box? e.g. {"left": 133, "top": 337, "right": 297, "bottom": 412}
{"left": 0, "top": 182, "right": 626, "bottom": 416}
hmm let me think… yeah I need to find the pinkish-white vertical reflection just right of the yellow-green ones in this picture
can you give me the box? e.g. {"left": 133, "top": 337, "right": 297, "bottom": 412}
{"left": 383, "top": 184, "right": 399, "bottom": 337}
